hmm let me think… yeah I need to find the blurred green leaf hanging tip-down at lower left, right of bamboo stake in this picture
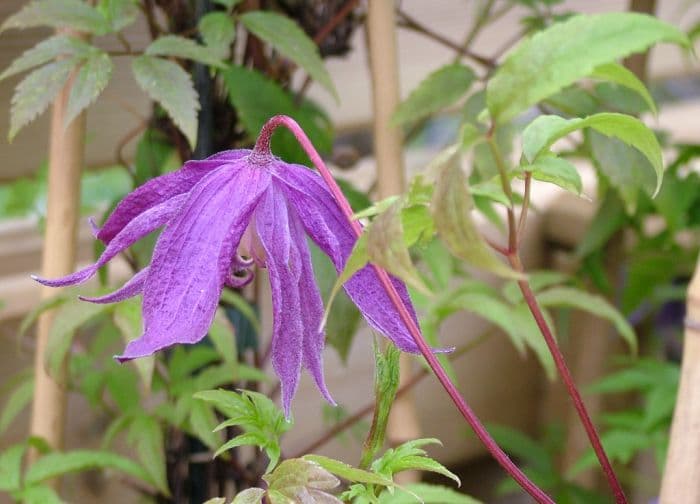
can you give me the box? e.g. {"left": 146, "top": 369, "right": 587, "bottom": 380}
{"left": 127, "top": 414, "right": 170, "bottom": 496}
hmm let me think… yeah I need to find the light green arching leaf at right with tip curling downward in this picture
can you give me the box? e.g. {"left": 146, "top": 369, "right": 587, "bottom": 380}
{"left": 523, "top": 112, "right": 664, "bottom": 194}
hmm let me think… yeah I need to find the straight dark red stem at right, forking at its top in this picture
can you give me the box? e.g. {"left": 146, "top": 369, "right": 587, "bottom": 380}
{"left": 487, "top": 127, "right": 627, "bottom": 504}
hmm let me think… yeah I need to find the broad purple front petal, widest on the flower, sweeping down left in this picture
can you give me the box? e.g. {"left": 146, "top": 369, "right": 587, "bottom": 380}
{"left": 118, "top": 161, "right": 270, "bottom": 361}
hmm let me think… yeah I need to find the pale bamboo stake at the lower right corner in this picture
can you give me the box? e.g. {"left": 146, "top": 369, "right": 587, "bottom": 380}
{"left": 661, "top": 261, "right": 700, "bottom": 504}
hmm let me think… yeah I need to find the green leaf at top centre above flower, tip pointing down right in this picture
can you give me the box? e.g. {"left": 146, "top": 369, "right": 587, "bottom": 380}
{"left": 240, "top": 11, "right": 338, "bottom": 100}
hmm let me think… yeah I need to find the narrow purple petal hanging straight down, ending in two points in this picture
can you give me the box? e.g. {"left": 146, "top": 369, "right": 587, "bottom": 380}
{"left": 255, "top": 179, "right": 335, "bottom": 416}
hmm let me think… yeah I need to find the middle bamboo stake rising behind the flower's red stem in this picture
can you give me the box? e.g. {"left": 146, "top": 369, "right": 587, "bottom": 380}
{"left": 367, "top": 0, "right": 420, "bottom": 468}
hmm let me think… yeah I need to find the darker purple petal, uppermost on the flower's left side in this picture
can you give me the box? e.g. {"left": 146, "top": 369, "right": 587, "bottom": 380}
{"left": 96, "top": 149, "right": 250, "bottom": 243}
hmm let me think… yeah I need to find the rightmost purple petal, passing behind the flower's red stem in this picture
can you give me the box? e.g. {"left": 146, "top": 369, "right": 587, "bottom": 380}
{"left": 273, "top": 163, "right": 419, "bottom": 353}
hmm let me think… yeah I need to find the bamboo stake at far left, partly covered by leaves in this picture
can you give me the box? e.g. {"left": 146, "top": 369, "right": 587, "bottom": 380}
{"left": 30, "top": 28, "right": 85, "bottom": 460}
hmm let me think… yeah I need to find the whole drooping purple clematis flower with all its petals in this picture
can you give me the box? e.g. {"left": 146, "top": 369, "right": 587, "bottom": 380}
{"left": 34, "top": 123, "right": 426, "bottom": 416}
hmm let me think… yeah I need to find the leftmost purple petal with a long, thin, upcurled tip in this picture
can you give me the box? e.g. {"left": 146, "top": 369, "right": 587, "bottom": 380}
{"left": 32, "top": 194, "right": 187, "bottom": 287}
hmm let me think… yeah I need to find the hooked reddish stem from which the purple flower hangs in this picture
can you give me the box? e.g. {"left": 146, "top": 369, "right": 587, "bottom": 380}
{"left": 254, "top": 116, "right": 554, "bottom": 504}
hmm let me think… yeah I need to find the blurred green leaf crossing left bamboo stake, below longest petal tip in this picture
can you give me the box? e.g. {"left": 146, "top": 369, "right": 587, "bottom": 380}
{"left": 46, "top": 299, "right": 114, "bottom": 377}
